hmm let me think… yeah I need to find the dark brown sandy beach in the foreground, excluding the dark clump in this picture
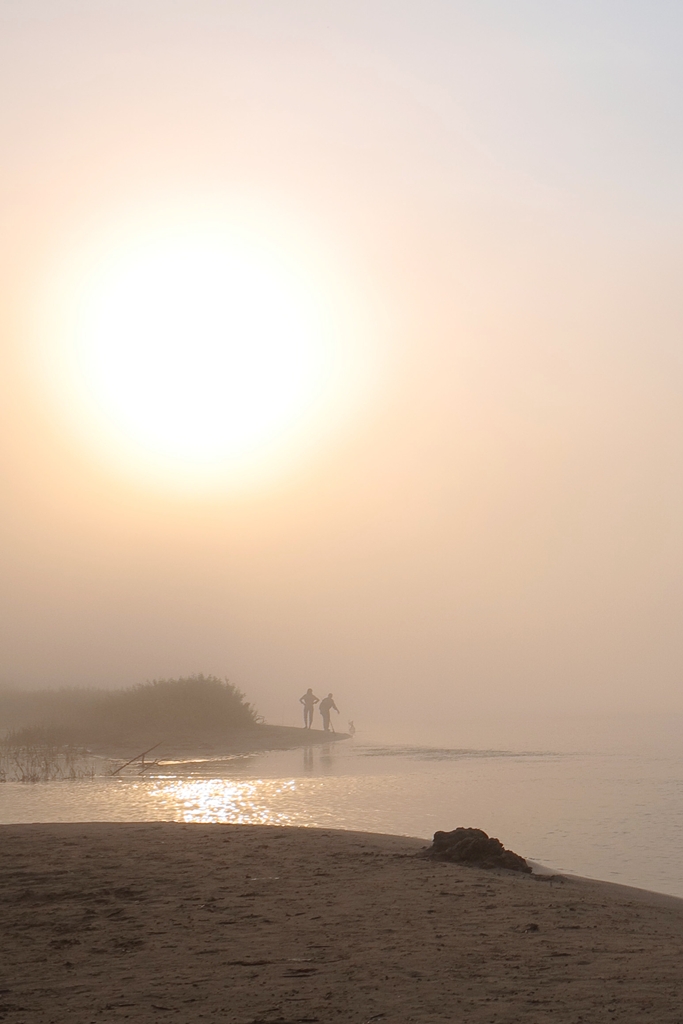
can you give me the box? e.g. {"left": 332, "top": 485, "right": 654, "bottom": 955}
{"left": 0, "top": 822, "right": 683, "bottom": 1024}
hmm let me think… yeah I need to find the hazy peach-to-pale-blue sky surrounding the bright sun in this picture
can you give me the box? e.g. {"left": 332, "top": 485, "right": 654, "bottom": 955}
{"left": 0, "top": 0, "right": 683, "bottom": 740}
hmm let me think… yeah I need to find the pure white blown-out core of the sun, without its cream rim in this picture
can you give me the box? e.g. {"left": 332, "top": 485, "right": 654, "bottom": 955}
{"left": 76, "top": 239, "right": 331, "bottom": 461}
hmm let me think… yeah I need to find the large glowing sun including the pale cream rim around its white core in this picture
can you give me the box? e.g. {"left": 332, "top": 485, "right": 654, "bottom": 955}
{"left": 34, "top": 206, "right": 370, "bottom": 483}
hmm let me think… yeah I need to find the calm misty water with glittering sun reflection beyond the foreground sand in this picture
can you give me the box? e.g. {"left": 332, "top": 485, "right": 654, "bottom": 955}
{"left": 0, "top": 742, "right": 683, "bottom": 896}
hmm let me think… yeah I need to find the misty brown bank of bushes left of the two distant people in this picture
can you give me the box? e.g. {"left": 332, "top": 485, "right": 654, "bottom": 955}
{"left": 0, "top": 675, "right": 259, "bottom": 750}
